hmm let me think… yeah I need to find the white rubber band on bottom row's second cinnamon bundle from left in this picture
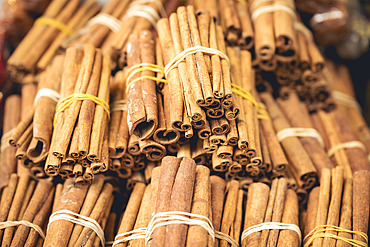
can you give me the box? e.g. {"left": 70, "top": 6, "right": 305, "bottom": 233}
{"left": 47, "top": 209, "right": 105, "bottom": 246}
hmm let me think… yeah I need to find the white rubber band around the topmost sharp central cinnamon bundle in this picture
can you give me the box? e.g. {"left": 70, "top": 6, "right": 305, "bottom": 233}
{"left": 164, "top": 46, "right": 230, "bottom": 78}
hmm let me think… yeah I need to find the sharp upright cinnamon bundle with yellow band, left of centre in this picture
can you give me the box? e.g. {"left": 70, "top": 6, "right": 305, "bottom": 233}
{"left": 45, "top": 45, "right": 111, "bottom": 183}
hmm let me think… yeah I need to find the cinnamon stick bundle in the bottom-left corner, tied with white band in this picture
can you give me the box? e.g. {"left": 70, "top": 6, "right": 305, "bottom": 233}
{"left": 0, "top": 174, "right": 56, "bottom": 247}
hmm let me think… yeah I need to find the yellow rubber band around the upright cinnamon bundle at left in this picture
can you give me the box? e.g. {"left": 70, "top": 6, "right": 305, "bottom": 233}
{"left": 54, "top": 93, "right": 110, "bottom": 126}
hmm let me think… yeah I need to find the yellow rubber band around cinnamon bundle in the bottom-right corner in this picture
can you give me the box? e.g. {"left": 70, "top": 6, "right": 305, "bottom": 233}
{"left": 303, "top": 225, "right": 368, "bottom": 247}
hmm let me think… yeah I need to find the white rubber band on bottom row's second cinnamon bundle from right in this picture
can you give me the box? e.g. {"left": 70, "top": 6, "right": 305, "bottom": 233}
{"left": 241, "top": 222, "right": 302, "bottom": 245}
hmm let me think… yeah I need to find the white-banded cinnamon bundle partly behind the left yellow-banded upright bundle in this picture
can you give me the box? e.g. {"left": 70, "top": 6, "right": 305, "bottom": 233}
{"left": 9, "top": 55, "right": 64, "bottom": 178}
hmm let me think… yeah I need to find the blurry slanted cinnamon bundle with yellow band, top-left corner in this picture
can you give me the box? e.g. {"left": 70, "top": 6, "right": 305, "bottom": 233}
{"left": 8, "top": 0, "right": 100, "bottom": 77}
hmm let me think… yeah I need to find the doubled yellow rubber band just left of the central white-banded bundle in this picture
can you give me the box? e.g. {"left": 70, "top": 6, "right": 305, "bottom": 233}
{"left": 126, "top": 63, "right": 167, "bottom": 93}
